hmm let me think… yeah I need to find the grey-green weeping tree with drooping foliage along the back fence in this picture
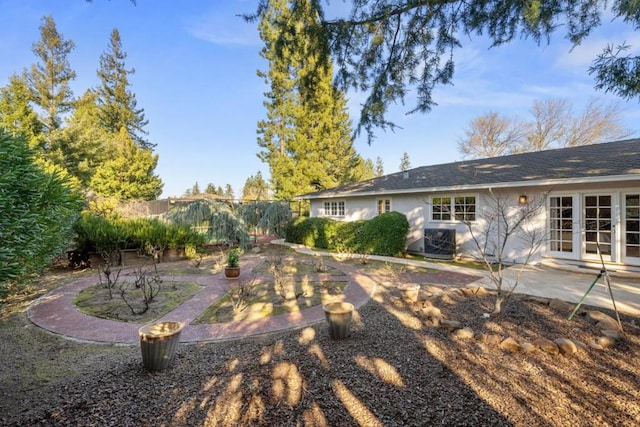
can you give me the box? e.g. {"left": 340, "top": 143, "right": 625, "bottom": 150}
{"left": 167, "top": 199, "right": 291, "bottom": 248}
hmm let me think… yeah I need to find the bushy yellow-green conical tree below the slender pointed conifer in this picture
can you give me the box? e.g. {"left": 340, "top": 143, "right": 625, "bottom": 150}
{"left": 91, "top": 129, "right": 162, "bottom": 200}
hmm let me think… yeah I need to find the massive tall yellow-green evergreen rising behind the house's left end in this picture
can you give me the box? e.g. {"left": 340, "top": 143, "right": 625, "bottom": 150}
{"left": 258, "top": 0, "right": 366, "bottom": 200}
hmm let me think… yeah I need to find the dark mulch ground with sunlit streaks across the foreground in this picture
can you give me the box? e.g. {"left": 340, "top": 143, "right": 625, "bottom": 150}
{"left": 0, "top": 274, "right": 640, "bottom": 426}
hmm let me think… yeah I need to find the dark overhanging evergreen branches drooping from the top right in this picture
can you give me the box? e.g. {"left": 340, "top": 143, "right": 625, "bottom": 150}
{"left": 245, "top": 0, "right": 640, "bottom": 142}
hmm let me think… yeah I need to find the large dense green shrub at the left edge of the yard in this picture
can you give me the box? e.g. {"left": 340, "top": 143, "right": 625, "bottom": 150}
{"left": 0, "top": 130, "right": 84, "bottom": 294}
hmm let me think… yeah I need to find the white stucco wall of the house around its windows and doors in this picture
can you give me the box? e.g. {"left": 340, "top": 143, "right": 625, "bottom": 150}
{"left": 311, "top": 180, "right": 640, "bottom": 268}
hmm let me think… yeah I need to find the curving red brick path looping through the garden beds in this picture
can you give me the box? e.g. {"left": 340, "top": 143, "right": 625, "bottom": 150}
{"left": 28, "top": 257, "right": 376, "bottom": 344}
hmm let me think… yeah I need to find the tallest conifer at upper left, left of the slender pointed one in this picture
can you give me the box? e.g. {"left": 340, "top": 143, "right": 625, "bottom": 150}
{"left": 27, "top": 16, "right": 76, "bottom": 140}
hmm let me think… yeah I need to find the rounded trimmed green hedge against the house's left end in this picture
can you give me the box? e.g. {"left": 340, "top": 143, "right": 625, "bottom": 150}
{"left": 285, "top": 212, "right": 409, "bottom": 256}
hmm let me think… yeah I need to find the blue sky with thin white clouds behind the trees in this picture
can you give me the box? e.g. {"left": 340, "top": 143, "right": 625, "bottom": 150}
{"left": 0, "top": 0, "right": 640, "bottom": 197}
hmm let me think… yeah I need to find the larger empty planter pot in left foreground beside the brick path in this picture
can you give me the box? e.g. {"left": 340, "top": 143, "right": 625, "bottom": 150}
{"left": 138, "top": 322, "right": 184, "bottom": 371}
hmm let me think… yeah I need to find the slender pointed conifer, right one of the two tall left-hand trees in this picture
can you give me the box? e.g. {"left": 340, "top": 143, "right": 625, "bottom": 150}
{"left": 97, "top": 29, "right": 155, "bottom": 148}
